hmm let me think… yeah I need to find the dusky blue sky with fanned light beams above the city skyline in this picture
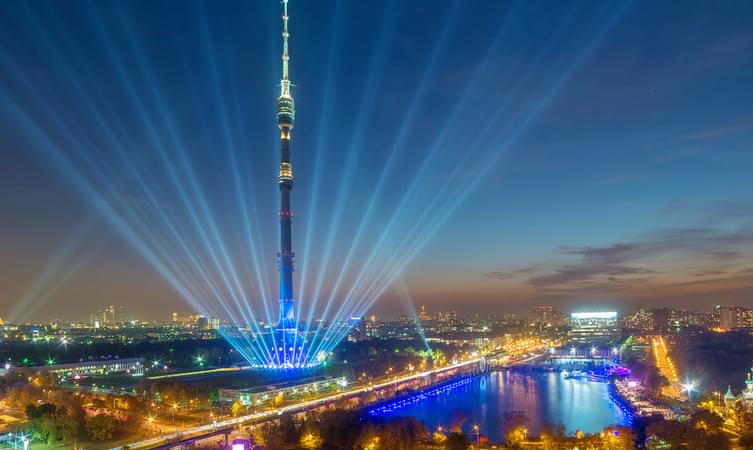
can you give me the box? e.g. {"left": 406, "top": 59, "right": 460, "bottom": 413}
{"left": 0, "top": 0, "right": 753, "bottom": 320}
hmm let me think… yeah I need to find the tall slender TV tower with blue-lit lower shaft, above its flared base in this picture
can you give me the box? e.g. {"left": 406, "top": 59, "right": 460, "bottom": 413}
{"left": 277, "top": 0, "right": 297, "bottom": 331}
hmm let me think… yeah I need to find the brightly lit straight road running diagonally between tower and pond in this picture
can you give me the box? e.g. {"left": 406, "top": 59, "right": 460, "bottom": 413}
{"left": 112, "top": 358, "right": 481, "bottom": 450}
